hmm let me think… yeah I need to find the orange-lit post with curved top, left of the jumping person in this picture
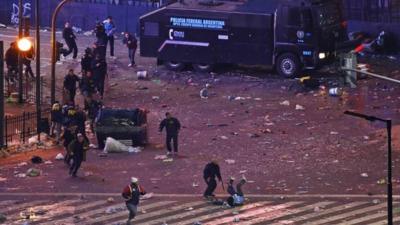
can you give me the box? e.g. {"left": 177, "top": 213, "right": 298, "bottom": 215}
{"left": 50, "top": 0, "right": 71, "bottom": 105}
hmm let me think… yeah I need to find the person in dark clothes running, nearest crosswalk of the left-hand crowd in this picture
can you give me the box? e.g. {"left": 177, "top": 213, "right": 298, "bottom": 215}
{"left": 68, "top": 133, "right": 87, "bottom": 177}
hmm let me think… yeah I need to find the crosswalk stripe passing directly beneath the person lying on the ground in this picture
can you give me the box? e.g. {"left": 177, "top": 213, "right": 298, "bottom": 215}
{"left": 177, "top": 202, "right": 286, "bottom": 225}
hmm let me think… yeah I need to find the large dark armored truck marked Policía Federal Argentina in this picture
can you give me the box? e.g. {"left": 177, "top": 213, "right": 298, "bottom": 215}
{"left": 140, "top": 0, "right": 347, "bottom": 78}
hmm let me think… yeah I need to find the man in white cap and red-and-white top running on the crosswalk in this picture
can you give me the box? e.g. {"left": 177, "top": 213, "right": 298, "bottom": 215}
{"left": 122, "top": 177, "right": 146, "bottom": 225}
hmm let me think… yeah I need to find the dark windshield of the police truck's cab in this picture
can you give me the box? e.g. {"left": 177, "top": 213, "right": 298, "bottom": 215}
{"left": 316, "top": 4, "right": 341, "bottom": 27}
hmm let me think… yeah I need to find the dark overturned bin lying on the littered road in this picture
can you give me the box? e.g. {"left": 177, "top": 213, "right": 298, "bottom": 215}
{"left": 95, "top": 108, "right": 148, "bottom": 149}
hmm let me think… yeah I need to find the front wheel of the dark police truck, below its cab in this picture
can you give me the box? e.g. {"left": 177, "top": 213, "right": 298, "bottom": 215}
{"left": 276, "top": 53, "right": 300, "bottom": 78}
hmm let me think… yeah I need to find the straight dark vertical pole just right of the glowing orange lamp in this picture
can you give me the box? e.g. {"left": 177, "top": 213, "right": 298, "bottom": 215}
{"left": 35, "top": 0, "right": 42, "bottom": 143}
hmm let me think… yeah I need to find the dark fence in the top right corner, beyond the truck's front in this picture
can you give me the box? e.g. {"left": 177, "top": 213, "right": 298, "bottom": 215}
{"left": 343, "top": 0, "right": 400, "bottom": 23}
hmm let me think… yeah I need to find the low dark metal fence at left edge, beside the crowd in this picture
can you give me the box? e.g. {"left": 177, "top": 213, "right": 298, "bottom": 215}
{"left": 4, "top": 109, "right": 50, "bottom": 147}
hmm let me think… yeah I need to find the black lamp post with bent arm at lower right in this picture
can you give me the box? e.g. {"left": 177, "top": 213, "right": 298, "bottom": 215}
{"left": 344, "top": 111, "right": 393, "bottom": 225}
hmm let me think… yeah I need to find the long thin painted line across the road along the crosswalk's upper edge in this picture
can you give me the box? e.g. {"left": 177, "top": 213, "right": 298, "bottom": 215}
{"left": 0, "top": 192, "right": 400, "bottom": 199}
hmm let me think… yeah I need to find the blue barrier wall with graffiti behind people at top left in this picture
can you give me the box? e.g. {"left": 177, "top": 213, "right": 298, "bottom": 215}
{"left": 0, "top": 0, "right": 157, "bottom": 33}
